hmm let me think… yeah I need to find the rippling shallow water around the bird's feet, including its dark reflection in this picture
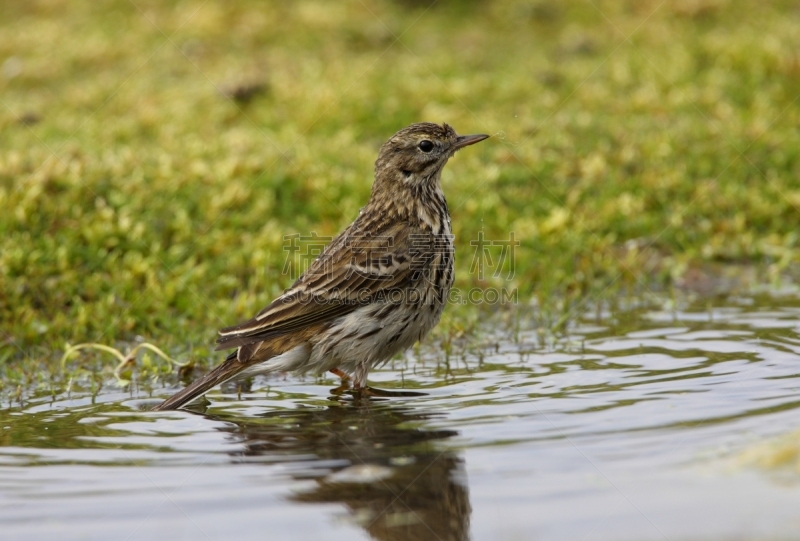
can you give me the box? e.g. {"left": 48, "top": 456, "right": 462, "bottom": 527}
{"left": 0, "top": 293, "right": 800, "bottom": 541}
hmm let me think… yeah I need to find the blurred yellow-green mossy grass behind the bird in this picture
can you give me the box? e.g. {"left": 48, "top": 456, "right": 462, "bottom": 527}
{"left": 0, "top": 0, "right": 800, "bottom": 386}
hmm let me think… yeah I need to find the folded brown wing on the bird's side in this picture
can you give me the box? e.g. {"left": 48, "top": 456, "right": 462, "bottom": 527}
{"left": 217, "top": 222, "right": 434, "bottom": 350}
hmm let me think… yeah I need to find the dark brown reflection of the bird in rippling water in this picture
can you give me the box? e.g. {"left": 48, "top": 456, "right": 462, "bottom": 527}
{"left": 205, "top": 400, "right": 471, "bottom": 541}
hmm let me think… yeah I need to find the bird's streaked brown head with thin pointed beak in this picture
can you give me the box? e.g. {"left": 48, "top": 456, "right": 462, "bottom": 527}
{"left": 375, "top": 122, "right": 489, "bottom": 185}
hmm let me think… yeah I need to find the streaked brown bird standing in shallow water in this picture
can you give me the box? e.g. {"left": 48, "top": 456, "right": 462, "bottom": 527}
{"left": 154, "top": 122, "right": 489, "bottom": 410}
